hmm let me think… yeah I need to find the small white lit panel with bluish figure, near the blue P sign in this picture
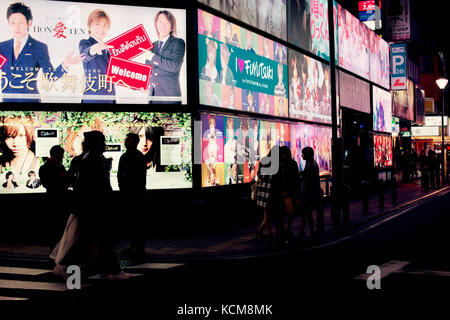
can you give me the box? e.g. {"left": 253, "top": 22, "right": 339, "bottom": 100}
{"left": 372, "top": 86, "right": 392, "bottom": 132}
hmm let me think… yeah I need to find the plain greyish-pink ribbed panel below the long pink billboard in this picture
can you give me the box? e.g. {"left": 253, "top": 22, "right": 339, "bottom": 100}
{"left": 339, "top": 71, "right": 370, "bottom": 113}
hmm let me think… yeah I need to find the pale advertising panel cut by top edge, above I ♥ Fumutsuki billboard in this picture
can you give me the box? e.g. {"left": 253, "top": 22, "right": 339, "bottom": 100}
{"left": 198, "top": 0, "right": 286, "bottom": 40}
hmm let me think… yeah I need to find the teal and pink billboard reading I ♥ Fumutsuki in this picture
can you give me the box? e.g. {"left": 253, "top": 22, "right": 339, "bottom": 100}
{"left": 198, "top": 10, "right": 288, "bottom": 117}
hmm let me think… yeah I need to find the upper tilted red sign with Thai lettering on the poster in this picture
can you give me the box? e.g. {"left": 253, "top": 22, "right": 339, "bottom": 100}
{"left": 105, "top": 24, "right": 154, "bottom": 60}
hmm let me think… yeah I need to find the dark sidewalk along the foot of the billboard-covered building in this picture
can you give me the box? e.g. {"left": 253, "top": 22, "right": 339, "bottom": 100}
{"left": 0, "top": 179, "right": 450, "bottom": 263}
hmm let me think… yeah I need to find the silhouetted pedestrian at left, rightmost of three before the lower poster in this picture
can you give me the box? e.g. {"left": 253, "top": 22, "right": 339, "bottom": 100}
{"left": 117, "top": 133, "right": 147, "bottom": 261}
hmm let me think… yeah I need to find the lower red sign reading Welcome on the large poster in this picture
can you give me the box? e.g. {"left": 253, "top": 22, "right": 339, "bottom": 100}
{"left": 106, "top": 57, "right": 152, "bottom": 90}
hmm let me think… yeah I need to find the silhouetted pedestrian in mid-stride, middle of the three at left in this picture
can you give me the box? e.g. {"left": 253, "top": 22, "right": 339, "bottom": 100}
{"left": 54, "top": 131, "right": 129, "bottom": 280}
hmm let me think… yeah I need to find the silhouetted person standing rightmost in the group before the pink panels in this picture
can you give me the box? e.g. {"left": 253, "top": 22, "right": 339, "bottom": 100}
{"left": 299, "top": 147, "right": 321, "bottom": 239}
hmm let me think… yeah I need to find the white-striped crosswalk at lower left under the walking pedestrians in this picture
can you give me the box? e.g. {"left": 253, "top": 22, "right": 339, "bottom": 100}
{"left": 0, "top": 261, "right": 184, "bottom": 305}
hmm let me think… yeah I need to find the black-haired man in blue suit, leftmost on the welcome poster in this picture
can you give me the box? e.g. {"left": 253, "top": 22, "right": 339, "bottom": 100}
{"left": 0, "top": 3, "right": 83, "bottom": 102}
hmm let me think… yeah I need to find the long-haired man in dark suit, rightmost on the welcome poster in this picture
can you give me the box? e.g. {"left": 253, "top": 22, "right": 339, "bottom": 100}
{"left": 142, "top": 10, "right": 186, "bottom": 104}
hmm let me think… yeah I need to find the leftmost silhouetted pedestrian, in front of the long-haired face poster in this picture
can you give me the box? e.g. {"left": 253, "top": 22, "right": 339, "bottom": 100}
{"left": 39, "top": 145, "right": 68, "bottom": 248}
